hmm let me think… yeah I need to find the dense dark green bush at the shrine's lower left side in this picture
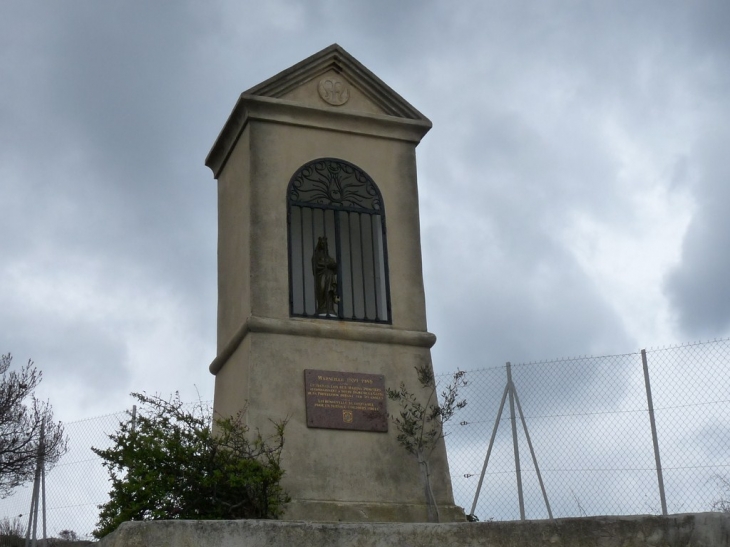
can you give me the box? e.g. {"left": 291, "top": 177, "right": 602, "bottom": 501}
{"left": 92, "top": 393, "right": 289, "bottom": 538}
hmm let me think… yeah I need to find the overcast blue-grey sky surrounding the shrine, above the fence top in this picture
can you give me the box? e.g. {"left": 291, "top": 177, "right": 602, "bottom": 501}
{"left": 0, "top": 0, "right": 730, "bottom": 421}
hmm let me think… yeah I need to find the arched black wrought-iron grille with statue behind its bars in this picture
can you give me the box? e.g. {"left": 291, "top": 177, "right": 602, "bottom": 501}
{"left": 287, "top": 158, "right": 390, "bottom": 323}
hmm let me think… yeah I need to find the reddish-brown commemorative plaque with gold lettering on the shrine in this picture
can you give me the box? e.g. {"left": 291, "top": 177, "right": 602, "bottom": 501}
{"left": 304, "top": 369, "right": 388, "bottom": 432}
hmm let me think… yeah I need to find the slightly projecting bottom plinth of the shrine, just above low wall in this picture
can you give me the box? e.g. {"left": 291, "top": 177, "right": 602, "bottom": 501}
{"left": 282, "top": 500, "right": 466, "bottom": 522}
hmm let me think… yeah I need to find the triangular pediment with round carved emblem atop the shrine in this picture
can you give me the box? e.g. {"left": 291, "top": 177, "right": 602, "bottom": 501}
{"left": 243, "top": 44, "right": 430, "bottom": 123}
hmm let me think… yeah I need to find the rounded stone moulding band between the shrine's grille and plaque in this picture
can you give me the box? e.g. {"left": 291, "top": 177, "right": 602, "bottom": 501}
{"left": 208, "top": 315, "right": 436, "bottom": 375}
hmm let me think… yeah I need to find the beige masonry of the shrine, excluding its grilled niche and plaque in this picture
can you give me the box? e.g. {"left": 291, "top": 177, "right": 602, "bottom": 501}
{"left": 206, "top": 45, "right": 458, "bottom": 522}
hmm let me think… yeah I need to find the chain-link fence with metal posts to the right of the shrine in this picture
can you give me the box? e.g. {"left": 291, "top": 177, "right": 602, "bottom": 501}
{"left": 440, "top": 340, "right": 730, "bottom": 520}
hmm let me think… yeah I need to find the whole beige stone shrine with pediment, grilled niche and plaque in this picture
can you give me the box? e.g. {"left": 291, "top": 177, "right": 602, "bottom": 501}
{"left": 206, "top": 45, "right": 464, "bottom": 522}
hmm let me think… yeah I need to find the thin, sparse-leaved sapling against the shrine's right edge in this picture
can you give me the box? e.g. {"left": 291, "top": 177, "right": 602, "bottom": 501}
{"left": 387, "top": 365, "right": 466, "bottom": 522}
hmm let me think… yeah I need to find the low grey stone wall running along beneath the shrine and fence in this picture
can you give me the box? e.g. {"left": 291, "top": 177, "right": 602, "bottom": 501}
{"left": 98, "top": 513, "right": 730, "bottom": 547}
